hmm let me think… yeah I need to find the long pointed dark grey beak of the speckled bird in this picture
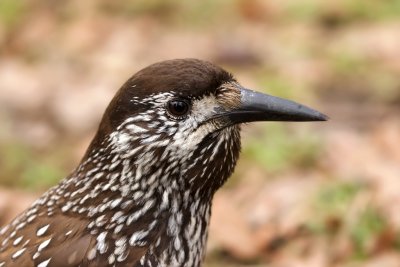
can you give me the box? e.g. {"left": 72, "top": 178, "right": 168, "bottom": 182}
{"left": 226, "top": 87, "right": 328, "bottom": 124}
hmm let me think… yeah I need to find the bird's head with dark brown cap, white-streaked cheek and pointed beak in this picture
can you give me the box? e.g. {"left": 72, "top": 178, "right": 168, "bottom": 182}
{"left": 88, "top": 59, "right": 326, "bottom": 199}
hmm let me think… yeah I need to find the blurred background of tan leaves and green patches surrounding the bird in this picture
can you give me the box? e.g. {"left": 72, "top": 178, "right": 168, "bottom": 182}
{"left": 0, "top": 0, "right": 400, "bottom": 267}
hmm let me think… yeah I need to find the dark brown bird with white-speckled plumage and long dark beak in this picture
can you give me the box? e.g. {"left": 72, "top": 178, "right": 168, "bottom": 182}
{"left": 0, "top": 59, "right": 327, "bottom": 267}
